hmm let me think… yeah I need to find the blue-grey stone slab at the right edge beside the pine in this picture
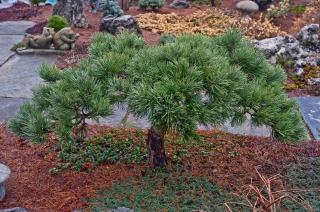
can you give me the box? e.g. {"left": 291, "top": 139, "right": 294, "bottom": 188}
{"left": 297, "top": 97, "right": 320, "bottom": 141}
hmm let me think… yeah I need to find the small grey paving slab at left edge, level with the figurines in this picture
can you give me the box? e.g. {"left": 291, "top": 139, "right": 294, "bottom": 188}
{"left": 0, "top": 35, "right": 24, "bottom": 67}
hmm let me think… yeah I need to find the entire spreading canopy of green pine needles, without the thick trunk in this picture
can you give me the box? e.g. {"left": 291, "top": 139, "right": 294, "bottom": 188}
{"left": 10, "top": 31, "right": 305, "bottom": 154}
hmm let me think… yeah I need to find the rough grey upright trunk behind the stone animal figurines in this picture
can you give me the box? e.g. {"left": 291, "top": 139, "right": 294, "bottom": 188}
{"left": 53, "top": 0, "right": 88, "bottom": 28}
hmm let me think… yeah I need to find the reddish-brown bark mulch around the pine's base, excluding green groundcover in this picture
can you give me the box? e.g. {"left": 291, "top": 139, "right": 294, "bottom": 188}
{"left": 0, "top": 126, "right": 320, "bottom": 211}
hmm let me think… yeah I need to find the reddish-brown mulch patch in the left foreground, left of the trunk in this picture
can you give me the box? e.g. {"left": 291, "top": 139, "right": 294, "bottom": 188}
{"left": 0, "top": 127, "right": 144, "bottom": 212}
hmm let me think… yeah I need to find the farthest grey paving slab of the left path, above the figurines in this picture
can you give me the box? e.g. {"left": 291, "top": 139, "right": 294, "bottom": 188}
{"left": 0, "top": 21, "right": 35, "bottom": 35}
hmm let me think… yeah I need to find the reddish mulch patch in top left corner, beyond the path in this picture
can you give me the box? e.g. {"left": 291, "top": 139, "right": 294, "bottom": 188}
{"left": 0, "top": 2, "right": 41, "bottom": 22}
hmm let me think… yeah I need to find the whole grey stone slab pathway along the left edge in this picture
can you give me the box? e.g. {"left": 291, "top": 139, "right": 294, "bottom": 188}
{"left": 0, "top": 21, "right": 56, "bottom": 122}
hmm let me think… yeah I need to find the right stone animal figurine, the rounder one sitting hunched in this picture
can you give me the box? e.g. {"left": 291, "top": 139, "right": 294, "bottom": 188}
{"left": 53, "top": 27, "right": 79, "bottom": 51}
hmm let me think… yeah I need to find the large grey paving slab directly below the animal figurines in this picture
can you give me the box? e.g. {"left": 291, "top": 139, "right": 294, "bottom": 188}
{"left": 0, "top": 55, "right": 57, "bottom": 98}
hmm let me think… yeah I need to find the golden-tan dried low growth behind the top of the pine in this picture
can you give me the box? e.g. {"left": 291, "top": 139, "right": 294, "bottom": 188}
{"left": 137, "top": 9, "right": 285, "bottom": 39}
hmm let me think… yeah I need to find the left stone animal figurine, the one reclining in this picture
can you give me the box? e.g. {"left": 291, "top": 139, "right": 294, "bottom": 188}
{"left": 26, "top": 27, "right": 54, "bottom": 49}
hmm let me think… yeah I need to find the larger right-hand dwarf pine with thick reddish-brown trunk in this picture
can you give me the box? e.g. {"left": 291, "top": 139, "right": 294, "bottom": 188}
{"left": 129, "top": 31, "right": 305, "bottom": 166}
